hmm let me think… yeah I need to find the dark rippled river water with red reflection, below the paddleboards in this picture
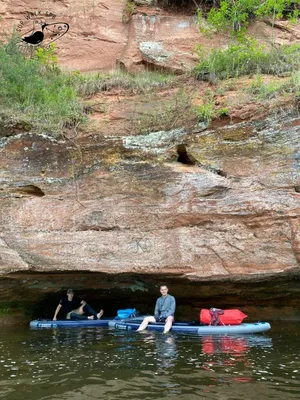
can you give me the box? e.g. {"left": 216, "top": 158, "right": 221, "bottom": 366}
{"left": 0, "top": 322, "right": 300, "bottom": 400}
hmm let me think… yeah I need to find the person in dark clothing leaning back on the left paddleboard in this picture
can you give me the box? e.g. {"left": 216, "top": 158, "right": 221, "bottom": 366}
{"left": 53, "top": 289, "right": 103, "bottom": 321}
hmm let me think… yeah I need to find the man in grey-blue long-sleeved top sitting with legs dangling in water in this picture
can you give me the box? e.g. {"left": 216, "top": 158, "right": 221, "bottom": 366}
{"left": 138, "top": 285, "right": 176, "bottom": 333}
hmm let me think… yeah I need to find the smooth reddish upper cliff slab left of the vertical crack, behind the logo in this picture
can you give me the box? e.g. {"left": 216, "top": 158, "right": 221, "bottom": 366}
{"left": 0, "top": 0, "right": 128, "bottom": 71}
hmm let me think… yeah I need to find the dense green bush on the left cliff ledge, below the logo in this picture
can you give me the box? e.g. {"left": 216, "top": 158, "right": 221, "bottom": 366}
{"left": 0, "top": 39, "right": 83, "bottom": 135}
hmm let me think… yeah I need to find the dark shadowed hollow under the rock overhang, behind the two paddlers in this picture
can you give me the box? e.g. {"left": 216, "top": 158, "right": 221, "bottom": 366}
{"left": 0, "top": 271, "right": 300, "bottom": 322}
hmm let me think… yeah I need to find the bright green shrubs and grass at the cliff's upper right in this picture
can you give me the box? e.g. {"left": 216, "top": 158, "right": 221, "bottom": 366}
{"left": 195, "top": 0, "right": 300, "bottom": 83}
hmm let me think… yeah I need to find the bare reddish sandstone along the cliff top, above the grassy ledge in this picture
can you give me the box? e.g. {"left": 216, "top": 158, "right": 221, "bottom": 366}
{"left": 0, "top": 0, "right": 300, "bottom": 73}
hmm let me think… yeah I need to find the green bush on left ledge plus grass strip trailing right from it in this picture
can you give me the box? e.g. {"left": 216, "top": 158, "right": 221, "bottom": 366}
{"left": 0, "top": 38, "right": 173, "bottom": 136}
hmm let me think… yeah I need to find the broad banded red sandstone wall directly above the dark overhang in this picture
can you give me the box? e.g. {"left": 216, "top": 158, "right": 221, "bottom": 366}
{"left": 0, "top": 115, "right": 300, "bottom": 279}
